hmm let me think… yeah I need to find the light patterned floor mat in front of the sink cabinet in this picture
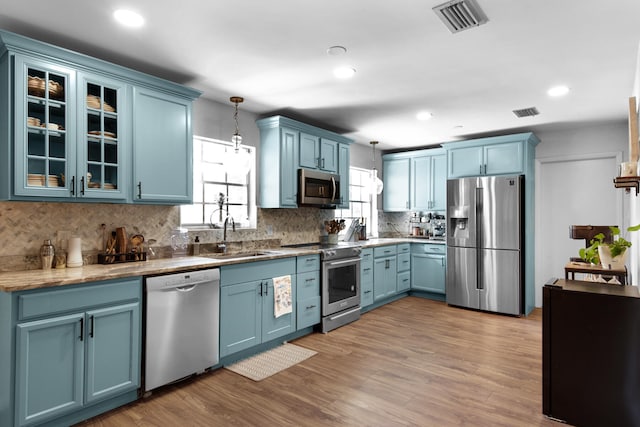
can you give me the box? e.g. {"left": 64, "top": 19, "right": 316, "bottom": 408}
{"left": 225, "top": 343, "right": 317, "bottom": 381}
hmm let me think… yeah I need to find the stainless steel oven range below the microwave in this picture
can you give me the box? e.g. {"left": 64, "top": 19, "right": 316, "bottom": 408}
{"left": 320, "top": 244, "right": 362, "bottom": 332}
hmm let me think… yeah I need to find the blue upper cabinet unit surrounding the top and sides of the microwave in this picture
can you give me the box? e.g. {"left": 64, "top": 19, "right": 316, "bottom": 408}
{"left": 256, "top": 116, "right": 353, "bottom": 208}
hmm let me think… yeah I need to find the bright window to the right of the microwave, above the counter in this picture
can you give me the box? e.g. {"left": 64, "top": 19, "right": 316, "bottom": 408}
{"left": 336, "top": 167, "right": 378, "bottom": 236}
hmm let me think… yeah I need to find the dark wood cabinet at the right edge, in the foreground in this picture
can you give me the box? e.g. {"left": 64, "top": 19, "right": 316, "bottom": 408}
{"left": 542, "top": 279, "right": 640, "bottom": 427}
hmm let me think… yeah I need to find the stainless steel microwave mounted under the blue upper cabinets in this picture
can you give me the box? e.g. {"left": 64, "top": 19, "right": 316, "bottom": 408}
{"left": 298, "top": 168, "right": 341, "bottom": 208}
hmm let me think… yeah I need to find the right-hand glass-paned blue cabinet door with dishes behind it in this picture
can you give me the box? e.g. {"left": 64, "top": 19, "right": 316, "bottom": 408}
{"left": 77, "top": 73, "right": 131, "bottom": 199}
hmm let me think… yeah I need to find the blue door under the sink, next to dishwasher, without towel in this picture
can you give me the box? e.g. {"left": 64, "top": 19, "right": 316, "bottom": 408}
{"left": 220, "top": 281, "right": 262, "bottom": 357}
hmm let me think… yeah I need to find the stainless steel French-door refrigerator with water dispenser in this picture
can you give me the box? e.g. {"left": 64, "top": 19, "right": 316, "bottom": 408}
{"left": 446, "top": 175, "right": 524, "bottom": 315}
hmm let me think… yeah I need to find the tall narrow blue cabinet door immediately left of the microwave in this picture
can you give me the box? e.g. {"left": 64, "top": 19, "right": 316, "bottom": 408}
{"left": 280, "top": 128, "right": 299, "bottom": 208}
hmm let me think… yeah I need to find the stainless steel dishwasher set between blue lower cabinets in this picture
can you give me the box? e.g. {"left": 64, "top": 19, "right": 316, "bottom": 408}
{"left": 144, "top": 268, "right": 220, "bottom": 392}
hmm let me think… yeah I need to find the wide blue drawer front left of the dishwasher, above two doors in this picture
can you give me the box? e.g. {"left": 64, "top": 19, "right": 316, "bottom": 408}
{"left": 18, "top": 277, "right": 142, "bottom": 320}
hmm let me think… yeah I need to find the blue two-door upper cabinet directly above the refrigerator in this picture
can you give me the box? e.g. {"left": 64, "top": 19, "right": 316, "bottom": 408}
{"left": 442, "top": 133, "right": 539, "bottom": 178}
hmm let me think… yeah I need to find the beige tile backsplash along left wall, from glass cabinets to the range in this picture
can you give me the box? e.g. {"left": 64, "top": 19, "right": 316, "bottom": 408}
{"left": 0, "top": 202, "right": 334, "bottom": 271}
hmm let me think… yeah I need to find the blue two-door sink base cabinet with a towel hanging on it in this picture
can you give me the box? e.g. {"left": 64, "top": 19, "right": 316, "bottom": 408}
{"left": 220, "top": 258, "right": 297, "bottom": 357}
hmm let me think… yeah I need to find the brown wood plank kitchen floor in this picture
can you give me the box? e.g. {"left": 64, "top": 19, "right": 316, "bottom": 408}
{"left": 83, "top": 297, "right": 560, "bottom": 427}
